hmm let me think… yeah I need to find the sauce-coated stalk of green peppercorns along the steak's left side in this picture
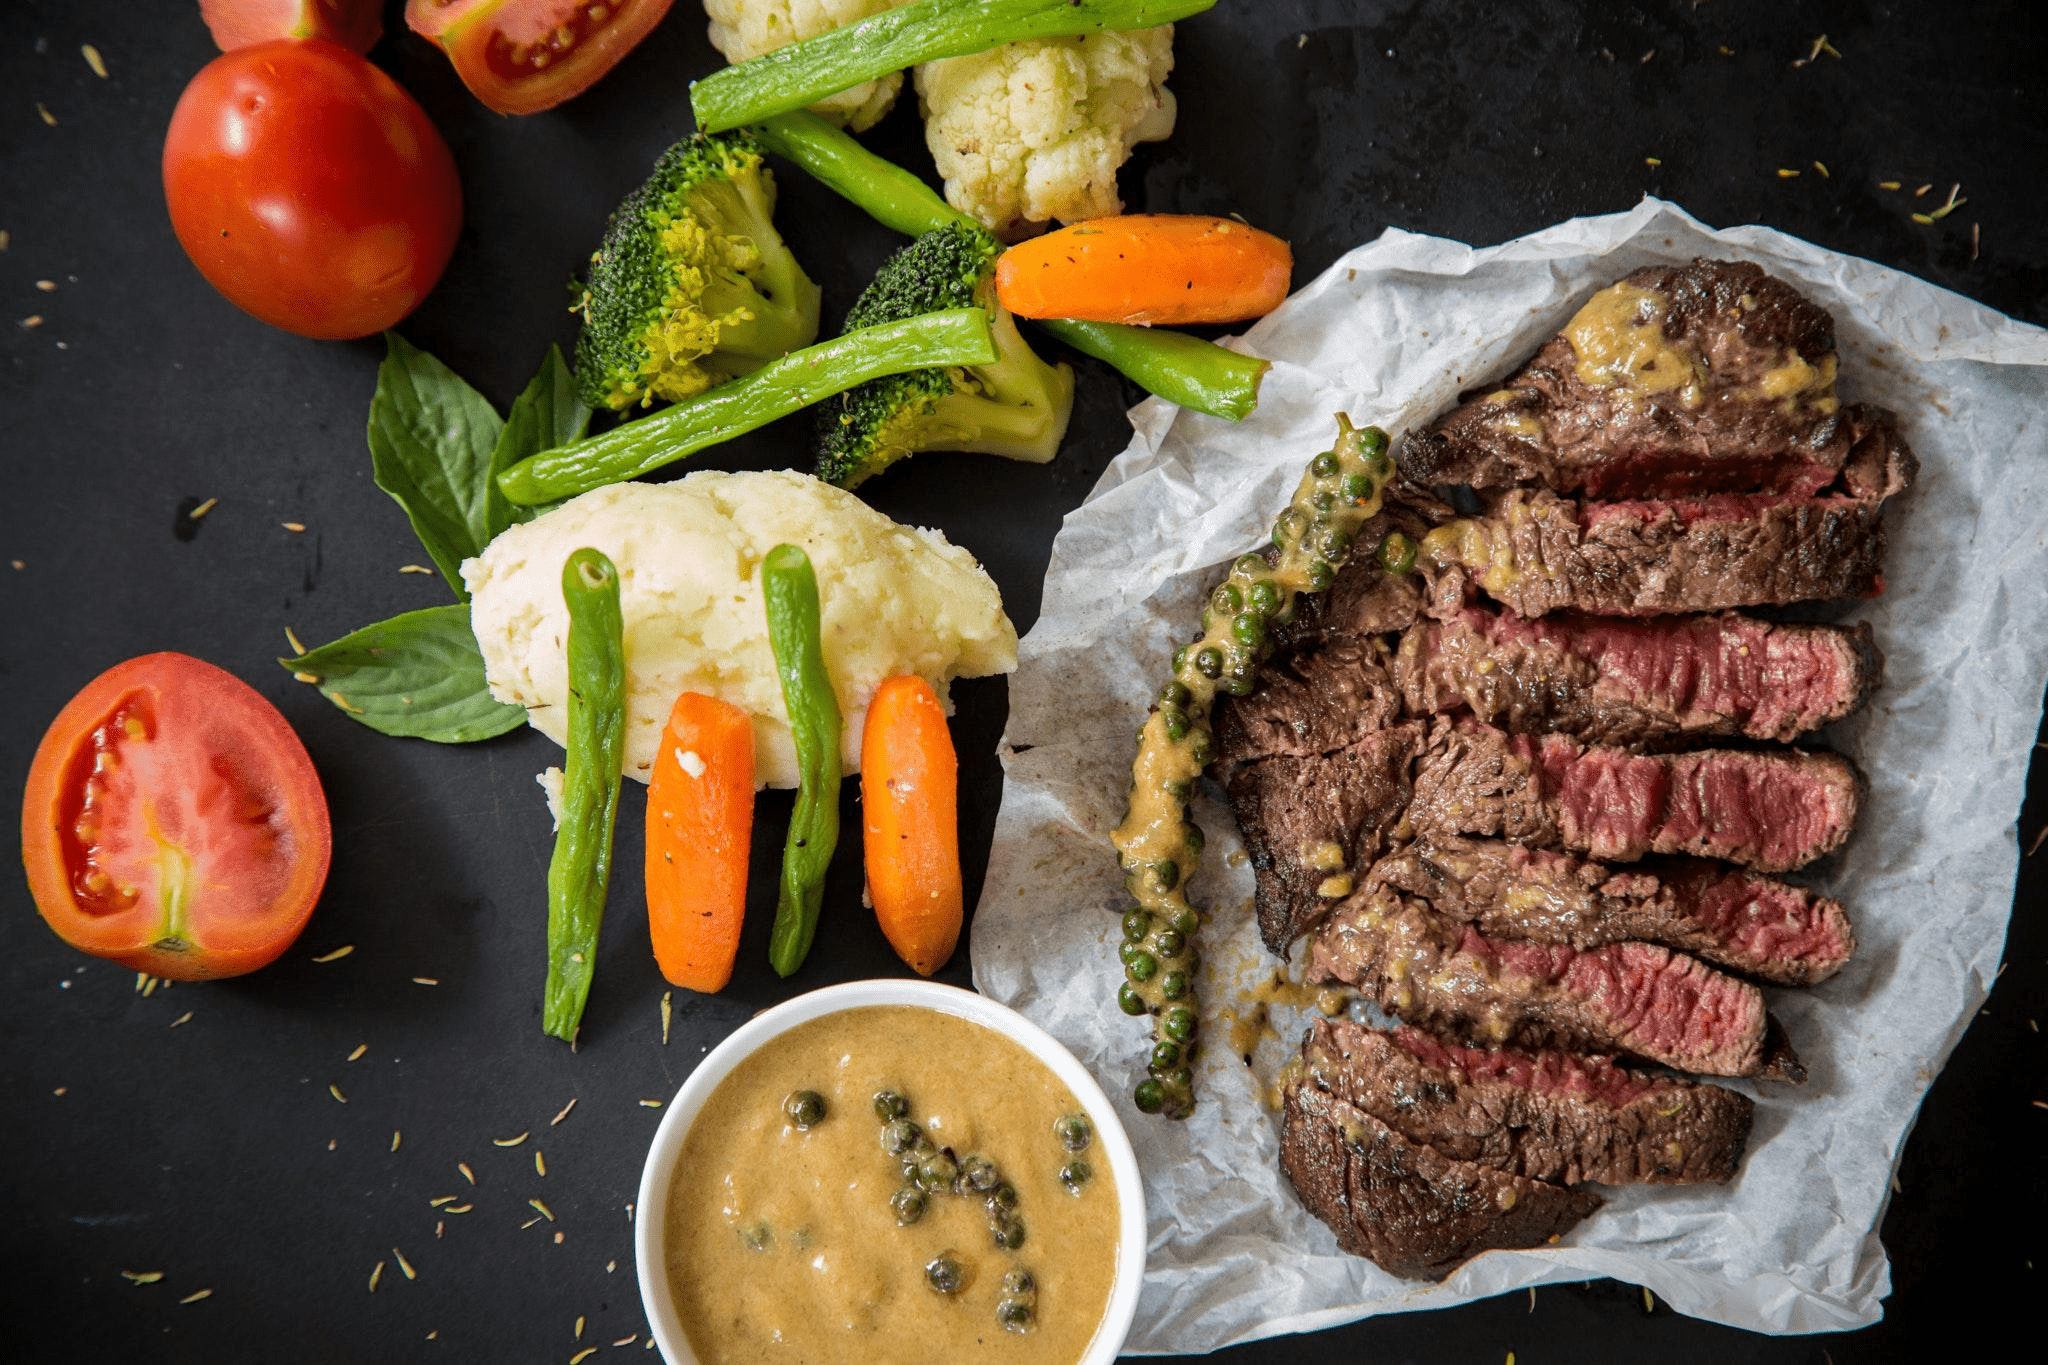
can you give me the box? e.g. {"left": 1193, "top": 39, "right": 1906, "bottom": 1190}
{"left": 1110, "top": 413, "right": 1413, "bottom": 1119}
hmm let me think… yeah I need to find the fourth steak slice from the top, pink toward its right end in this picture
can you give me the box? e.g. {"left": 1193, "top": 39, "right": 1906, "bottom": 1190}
{"left": 1407, "top": 720, "right": 1860, "bottom": 872}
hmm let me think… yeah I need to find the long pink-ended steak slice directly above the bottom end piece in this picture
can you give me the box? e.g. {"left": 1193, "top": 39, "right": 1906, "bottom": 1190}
{"left": 1307, "top": 884, "right": 1804, "bottom": 1081}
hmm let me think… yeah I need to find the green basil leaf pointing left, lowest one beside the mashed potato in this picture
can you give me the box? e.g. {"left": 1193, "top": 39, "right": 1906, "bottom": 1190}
{"left": 279, "top": 602, "right": 526, "bottom": 745}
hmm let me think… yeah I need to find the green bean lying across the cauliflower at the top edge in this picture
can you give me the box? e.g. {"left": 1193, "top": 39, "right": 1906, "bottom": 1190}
{"left": 690, "top": 0, "right": 1217, "bottom": 133}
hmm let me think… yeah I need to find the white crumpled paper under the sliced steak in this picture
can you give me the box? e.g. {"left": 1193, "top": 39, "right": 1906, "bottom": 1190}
{"left": 973, "top": 199, "right": 2048, "bottom": 1353}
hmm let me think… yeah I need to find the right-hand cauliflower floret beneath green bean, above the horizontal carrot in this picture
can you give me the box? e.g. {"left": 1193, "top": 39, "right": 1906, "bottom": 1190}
{"left": 918, "top": 25, "right": 1174, "bottom": 241}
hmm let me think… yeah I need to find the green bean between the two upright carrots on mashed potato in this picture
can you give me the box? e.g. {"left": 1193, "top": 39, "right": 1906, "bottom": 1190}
{"left": 762, "top": 544, "right": 840, "bottom": 976}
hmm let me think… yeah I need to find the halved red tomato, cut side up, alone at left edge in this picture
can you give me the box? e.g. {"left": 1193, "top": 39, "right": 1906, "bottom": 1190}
{"left": 20, "top": 653, "right": 334, "bottom": 980}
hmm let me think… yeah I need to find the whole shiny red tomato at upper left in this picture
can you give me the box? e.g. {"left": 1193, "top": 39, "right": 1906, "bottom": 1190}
{"left": 164, "top": 39, "right": 463, "bottom": 340}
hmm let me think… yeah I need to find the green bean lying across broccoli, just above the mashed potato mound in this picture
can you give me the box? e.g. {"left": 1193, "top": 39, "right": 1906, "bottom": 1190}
{"left": 498, "top": 309, "right": 995, "bottom": 505}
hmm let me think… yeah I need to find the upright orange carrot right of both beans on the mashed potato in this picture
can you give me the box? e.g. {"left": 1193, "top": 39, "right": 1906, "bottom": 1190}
{"left": 860, "top": 675, "right": 961, "bottom": 976}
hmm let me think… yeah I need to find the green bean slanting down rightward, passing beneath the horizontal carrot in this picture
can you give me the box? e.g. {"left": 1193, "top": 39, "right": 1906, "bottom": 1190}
{"left": 754, "top": 111, "right": 1272, "bottom": 422}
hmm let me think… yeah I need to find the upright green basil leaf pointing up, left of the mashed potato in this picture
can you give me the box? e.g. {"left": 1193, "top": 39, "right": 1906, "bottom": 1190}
{"left": 369, "top": 332, "right": 512, "bottom": 602}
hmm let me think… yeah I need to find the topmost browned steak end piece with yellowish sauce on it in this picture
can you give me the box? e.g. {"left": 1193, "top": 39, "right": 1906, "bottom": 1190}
{"left": 1401, "top": 260, "right": 1853, "bottom": 497}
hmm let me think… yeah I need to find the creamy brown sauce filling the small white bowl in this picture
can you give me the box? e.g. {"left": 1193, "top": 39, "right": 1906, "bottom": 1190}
{"left": 666, "top": 1007, "right": 1118, "bottom": 1365}
